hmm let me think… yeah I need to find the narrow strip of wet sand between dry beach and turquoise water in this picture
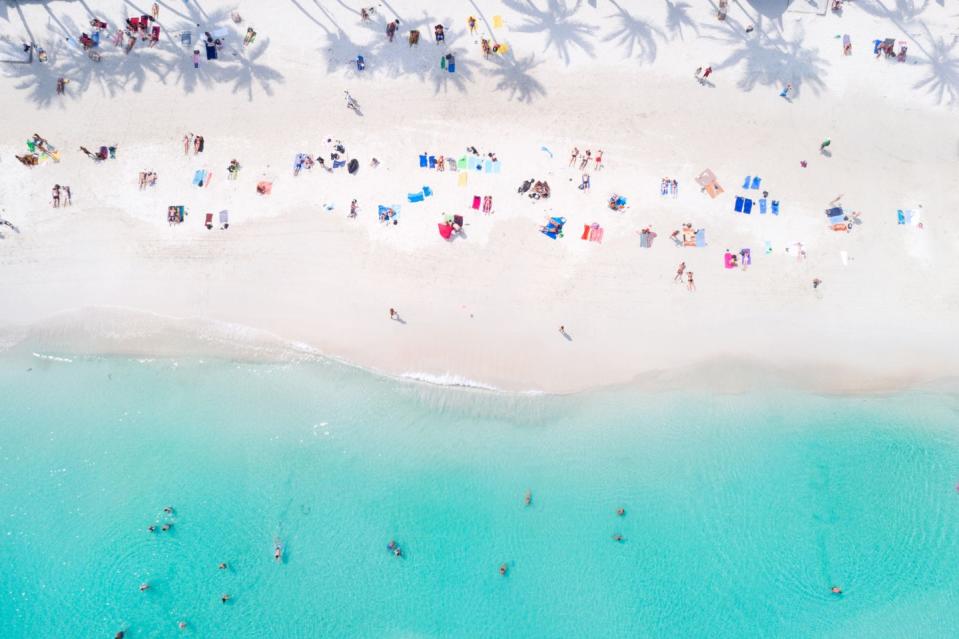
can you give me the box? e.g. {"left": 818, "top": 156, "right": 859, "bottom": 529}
{"left": 0, "top": 308, "right": 959, "bottom": 396}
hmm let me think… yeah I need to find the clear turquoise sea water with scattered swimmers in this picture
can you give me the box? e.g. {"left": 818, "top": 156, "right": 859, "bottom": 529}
{"left": 0, "top": 357, "right": 959, "bottom": 638}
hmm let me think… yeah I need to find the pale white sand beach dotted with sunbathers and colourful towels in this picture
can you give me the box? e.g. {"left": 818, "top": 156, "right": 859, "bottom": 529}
{"left": 0, "top": 0, "right": 959, "bottom": 392}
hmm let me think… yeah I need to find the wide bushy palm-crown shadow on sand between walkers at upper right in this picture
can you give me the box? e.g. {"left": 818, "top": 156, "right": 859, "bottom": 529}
{"left": 706, "top": 18, "right": 829, "bottom": 96}
